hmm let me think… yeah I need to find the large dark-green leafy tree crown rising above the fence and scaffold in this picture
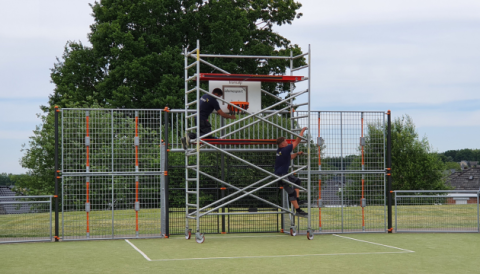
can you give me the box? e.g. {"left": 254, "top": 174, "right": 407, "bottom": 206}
{"left": 21, "top": 0, "right": 304, "bottom": 194}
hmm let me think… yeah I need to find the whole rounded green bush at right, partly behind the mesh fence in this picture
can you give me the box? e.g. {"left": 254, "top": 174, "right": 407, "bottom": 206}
{"left": 346, "top": 115, "right": 450, "bottom": 201}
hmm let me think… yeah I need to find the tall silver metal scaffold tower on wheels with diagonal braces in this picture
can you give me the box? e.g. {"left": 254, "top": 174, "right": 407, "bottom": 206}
{"left": 184, "top": 40, "right": 314, "bottom": 243}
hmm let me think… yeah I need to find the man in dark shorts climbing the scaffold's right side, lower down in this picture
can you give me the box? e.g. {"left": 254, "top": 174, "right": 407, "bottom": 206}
{"left": 275, "top": 127, "right": 308, "bottom": 217}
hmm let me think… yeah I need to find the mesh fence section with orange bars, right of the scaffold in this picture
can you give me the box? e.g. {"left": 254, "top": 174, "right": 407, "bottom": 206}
{"left": 295, "top": 111, "right": 387, "bottom": 233}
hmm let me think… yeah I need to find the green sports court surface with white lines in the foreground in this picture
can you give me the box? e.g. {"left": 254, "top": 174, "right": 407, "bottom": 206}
{"left": 0, "top": 233, "right": 480, "bottom": 274}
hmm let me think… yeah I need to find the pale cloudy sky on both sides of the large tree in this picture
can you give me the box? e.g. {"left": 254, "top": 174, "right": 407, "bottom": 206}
{"left": 0, "top": 0, "right": 480, "bottom": 174}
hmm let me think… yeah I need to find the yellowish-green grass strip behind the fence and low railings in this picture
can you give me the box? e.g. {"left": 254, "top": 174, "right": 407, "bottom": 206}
{"left": 0, "top": 204, "right": 477, "bottom": 239}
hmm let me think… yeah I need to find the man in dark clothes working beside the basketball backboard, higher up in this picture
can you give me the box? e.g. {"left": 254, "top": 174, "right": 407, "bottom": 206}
{"left": 181, "top": 88, "right": 237, "bottom": 150}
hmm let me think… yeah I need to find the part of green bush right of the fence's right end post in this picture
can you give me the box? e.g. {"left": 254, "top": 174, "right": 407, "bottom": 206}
{"left": 392, "top": 115, "right": 448, "bottom": 190}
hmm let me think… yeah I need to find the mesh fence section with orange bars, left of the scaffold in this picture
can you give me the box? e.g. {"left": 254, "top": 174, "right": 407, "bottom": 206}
{"left": 61, "top": 109, "right": 166, "bottom": 240}
